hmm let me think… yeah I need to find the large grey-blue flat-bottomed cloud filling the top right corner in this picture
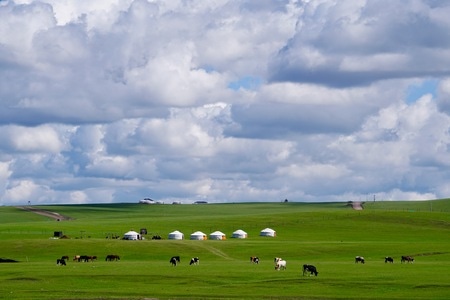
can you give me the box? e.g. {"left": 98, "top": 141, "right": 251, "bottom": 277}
{"left": 270, "top": 0, "right": 450, "bottom": 87}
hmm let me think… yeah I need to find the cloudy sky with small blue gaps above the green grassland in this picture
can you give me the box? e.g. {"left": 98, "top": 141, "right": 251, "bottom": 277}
{"left": 0, "top": 0, "right": 450, "bottom": 205}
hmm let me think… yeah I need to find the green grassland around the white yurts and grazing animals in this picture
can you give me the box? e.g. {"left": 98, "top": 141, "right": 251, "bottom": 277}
{"left": 0, "top": 199, "right": 450, "bottom": 299}
